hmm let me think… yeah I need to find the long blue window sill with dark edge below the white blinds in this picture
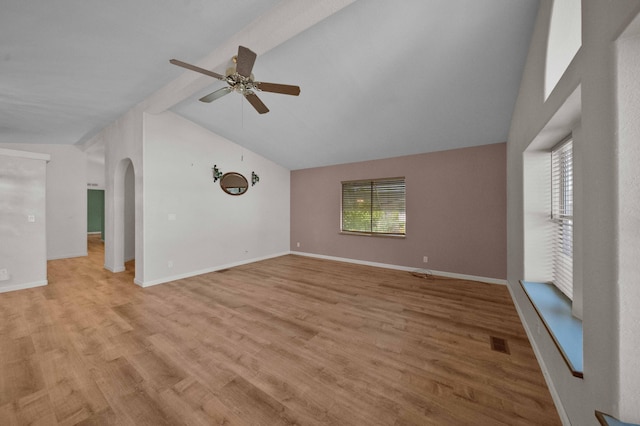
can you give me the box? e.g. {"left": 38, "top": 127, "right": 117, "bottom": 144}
{"left": 520, "top": 281, "right": 583, "bottom": 378}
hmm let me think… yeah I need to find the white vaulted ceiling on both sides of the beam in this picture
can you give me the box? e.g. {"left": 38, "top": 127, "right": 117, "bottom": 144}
{"left": 0, "top": 0, "right": 538, "bottom": 170}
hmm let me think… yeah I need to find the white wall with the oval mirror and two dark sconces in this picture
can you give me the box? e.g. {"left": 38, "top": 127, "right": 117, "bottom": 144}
{"left": 140, "top": 112, "right": 290, "bottom": 286}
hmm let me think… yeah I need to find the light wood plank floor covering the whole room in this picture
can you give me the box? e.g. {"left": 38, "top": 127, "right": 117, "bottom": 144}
{"left": 0, "top": 235, "right": 560, "bottom": 426}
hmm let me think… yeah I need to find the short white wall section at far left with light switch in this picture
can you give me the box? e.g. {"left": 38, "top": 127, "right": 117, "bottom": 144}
{"left": 0, "top": 148, "right": 49, "bottom": 292}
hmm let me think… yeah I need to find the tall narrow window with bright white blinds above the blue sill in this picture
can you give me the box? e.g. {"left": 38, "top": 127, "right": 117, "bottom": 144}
{"left": 551, "top": 137, "right": 573, "bottom": 300}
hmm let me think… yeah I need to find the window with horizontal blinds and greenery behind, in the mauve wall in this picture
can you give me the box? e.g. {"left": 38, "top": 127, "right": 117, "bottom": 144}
{"left": 341, "top": 177, "right": 406, "bottom": 236}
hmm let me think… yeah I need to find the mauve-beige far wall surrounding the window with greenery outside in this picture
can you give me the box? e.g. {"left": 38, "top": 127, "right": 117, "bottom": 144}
{"left": 291, "top": 143, "right": 506, "bottom": 279}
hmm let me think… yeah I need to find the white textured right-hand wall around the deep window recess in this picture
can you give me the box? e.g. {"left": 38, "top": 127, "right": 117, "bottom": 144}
{"left": 507, "top": 0, "right": 640, "bottom": 425}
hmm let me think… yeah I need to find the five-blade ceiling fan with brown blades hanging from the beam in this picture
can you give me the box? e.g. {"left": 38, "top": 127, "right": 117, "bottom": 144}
{"left": 169, "top": 46, "right": 300, "bottom": 114}
